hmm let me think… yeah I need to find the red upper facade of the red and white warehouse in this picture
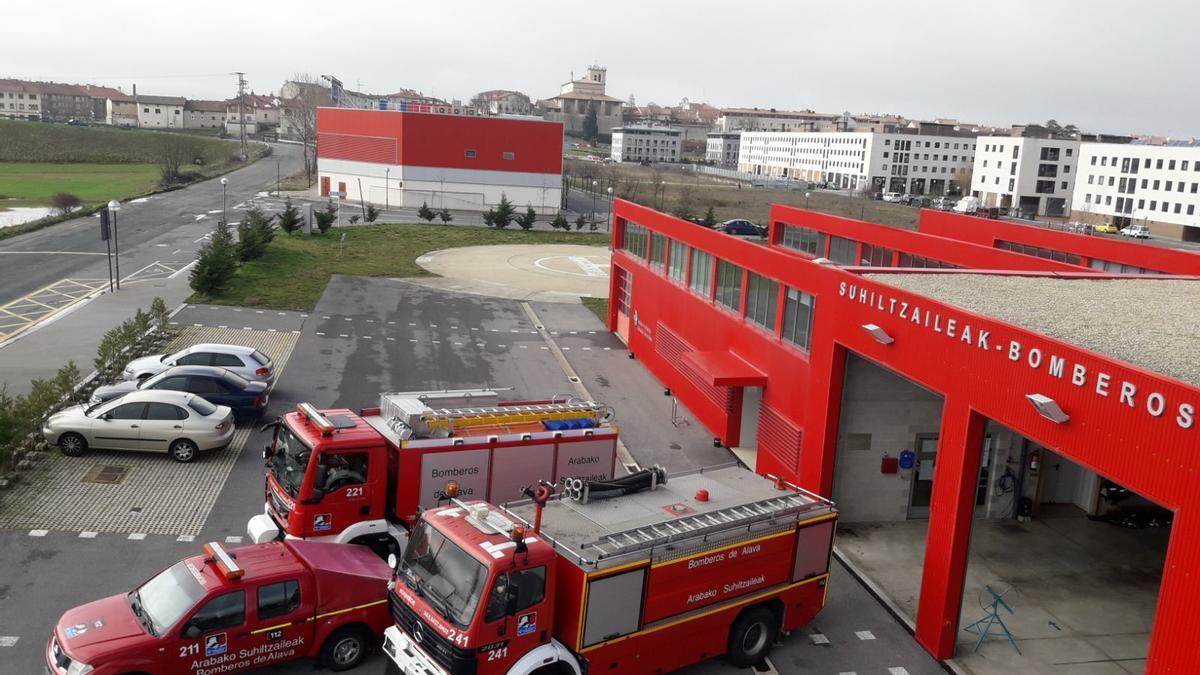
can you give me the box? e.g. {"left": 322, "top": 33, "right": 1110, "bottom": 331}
{"left": 317, "top": 108, "right": 563, "bottom": 174}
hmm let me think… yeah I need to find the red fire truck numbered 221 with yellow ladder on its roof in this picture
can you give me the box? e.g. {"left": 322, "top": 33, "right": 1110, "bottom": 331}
{"left": 247, "top": 389, "right": 618, "bottom": 556}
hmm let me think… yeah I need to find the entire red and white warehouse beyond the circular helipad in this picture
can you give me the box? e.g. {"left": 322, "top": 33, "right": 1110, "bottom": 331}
{"left": 317, "top": 108, "right": 563, "bottom": 213}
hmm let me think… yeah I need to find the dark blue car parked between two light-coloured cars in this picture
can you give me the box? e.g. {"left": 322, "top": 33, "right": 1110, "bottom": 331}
{"left": 89, "top": 365, "right": 268, "bottom": 419}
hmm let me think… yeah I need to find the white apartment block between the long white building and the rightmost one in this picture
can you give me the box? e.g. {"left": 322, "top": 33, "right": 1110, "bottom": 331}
{"left": 971, "top": 136, "right": 1080, "bottom": 213}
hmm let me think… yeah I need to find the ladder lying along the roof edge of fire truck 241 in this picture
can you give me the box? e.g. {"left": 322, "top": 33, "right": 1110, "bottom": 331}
{"left": 583, "top": 494, "right": 828, "bottom": 562}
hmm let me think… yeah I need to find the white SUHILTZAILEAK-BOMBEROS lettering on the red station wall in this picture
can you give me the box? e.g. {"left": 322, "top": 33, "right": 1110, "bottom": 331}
{"left": 838, "top": 281, "right": 1196, "bottom": 429}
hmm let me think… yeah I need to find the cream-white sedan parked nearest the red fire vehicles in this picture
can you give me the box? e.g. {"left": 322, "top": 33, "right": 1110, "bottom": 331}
{"left": 42, "top": 389, "right": 234, "bottom": 462}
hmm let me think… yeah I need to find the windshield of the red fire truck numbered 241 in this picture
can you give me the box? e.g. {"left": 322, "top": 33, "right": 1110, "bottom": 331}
{"left": 400, "top": 521, "right": 487, "bottom": 628}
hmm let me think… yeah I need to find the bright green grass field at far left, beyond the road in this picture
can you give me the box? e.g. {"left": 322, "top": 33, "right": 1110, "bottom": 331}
{"left": 0, "top": 162, "right": 158, "bottom": 207}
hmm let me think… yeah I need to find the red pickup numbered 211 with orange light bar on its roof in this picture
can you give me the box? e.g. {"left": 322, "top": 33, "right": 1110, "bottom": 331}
{"left": 46, "top": 540, "right": 391, "bottom": 675}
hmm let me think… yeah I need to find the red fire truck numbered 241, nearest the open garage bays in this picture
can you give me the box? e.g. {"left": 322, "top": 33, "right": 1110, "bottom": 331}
{"left": 384, "top": 465, "right": 836, "bottom": 675}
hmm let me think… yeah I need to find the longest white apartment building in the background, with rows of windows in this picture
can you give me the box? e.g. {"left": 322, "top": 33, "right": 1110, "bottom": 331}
{"left": 737, "top": 131, "right": 976, "bottom": 195}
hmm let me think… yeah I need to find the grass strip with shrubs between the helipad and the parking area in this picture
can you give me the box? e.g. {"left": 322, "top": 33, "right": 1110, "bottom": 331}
{"left": 188, "top": 225, "right": 608, "bottom": 311}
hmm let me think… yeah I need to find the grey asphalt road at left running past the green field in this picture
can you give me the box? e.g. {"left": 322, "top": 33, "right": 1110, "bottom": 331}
{"left": 0, "top": 144, "right": 302, "bottom": 305}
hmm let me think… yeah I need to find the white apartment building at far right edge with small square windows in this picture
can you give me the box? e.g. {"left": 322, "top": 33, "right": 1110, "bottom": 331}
{"left": 1072, "top": 143, "right": 1200, "bottom": 241}
